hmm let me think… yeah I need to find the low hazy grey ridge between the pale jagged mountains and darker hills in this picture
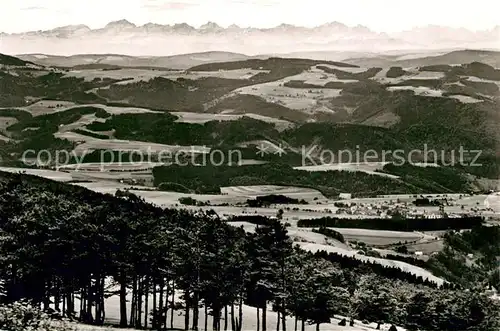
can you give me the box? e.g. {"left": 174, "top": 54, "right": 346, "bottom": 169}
{"left": 17, "top": 49, "right": 500, "bottom": 70}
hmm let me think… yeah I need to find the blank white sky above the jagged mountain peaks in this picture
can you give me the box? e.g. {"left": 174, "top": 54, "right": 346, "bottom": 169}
{"left": 0, "top": 0, "right": 500, "bottom": 33}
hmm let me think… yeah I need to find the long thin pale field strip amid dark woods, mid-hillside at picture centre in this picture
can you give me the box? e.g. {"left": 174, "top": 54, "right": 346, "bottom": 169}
{"left": 170, "top": 112, "right": 293, "bottom": 131}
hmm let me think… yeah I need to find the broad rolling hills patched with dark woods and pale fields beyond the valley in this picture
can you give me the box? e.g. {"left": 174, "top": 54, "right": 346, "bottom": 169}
{"left": 0, "top": 53, "right": 500, "bottom": 194}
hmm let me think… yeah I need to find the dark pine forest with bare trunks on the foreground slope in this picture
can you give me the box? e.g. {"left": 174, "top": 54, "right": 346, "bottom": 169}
{"left": 0, "top": 173, "right": 500, "bottom": 331}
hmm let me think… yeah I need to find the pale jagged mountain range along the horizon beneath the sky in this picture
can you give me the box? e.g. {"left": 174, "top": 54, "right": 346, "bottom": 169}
{"left": 0, "top": 20, "right": 500, "bottom": 56}
